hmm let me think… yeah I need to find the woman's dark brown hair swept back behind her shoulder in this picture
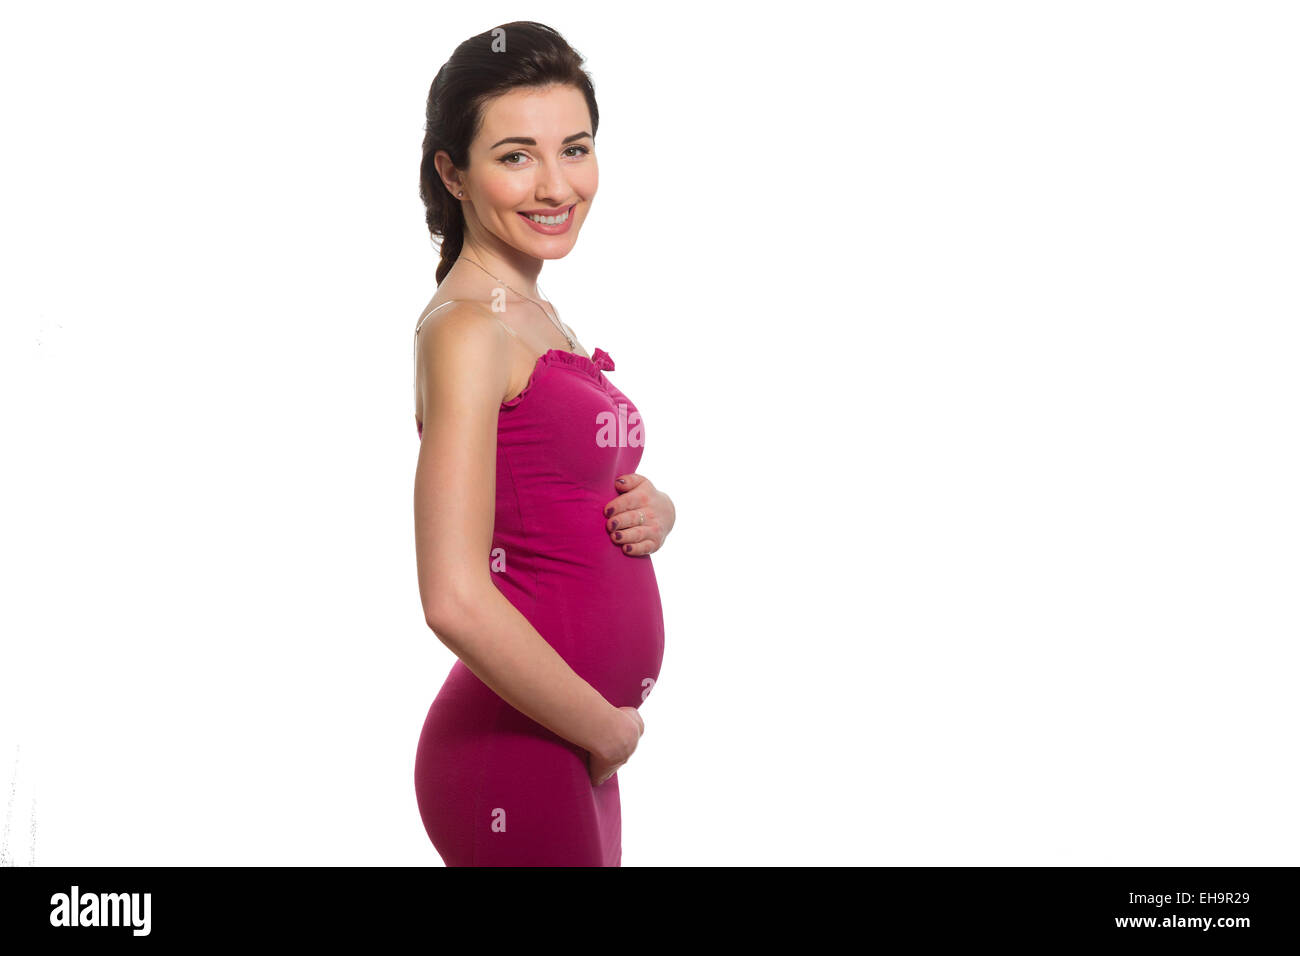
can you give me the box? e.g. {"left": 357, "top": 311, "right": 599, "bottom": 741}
{"left": 420, "top": 20, "right": 601, "bottom": 284}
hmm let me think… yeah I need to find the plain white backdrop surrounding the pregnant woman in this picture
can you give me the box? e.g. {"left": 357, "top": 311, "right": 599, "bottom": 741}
{"left": 0, "top": 1, "right": 1300, "bottom": 866}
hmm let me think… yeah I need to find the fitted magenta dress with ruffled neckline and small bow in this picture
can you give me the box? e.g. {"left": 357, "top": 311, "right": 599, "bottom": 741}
{"left": 415, "top": 338, "right": 663, "bottom": 866}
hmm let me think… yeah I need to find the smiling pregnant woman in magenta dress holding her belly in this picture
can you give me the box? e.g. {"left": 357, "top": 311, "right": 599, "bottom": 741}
{"left": 415, "top": 22, "right": 676, "bottom": 866}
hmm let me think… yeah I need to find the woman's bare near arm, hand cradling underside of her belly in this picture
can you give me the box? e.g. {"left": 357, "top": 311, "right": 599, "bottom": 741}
{"left": 415, "top": 310, "right": 638, "bottom": 761}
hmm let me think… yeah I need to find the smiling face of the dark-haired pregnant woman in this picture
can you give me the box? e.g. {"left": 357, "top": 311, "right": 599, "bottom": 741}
{"left": 452, "top": 86, "right": 598, "bottom": 259}
